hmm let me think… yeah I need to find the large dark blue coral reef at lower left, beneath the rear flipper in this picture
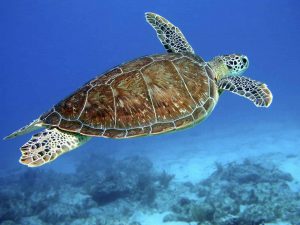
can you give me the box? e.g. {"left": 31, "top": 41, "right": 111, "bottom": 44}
{"left": 0, "top": 155, "right": 173, "bottom": 225}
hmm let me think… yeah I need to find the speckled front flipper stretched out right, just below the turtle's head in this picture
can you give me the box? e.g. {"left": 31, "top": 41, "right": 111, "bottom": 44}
{"left": 218, "top": 76, "right": 273, "bottom": 107}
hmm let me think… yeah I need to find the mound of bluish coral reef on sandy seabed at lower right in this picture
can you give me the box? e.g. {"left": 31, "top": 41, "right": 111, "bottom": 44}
{"left": 165, "top": 160, "right": 300, "bottom": 225}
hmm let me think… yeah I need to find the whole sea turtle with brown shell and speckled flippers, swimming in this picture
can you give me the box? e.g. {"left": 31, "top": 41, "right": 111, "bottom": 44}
{"left": 6, "top": 13, "right": 272, "bottom": 167}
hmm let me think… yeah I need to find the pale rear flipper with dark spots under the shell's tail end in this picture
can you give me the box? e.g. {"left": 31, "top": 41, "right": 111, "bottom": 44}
{"left": 19, "top": 128, "right": 90, "bottom": 167}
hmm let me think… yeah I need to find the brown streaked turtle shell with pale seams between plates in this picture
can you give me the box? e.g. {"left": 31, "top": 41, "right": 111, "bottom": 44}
{"left": 40, "top": 53, "right": 219, "bottom": 138}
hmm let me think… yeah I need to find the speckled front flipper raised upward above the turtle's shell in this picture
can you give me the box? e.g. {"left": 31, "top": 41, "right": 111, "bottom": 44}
{"left": 145, "top": 12, "right": 194, "bottom": 54}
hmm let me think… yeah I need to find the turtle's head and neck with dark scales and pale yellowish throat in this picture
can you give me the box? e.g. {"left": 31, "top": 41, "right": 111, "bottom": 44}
{"left": 210, "top": 54, "right": 249, "bottom": 80}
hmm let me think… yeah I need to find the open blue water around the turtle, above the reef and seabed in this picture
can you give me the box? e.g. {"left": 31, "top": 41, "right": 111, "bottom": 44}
{"left": 0, "top": 0, "right": 300, "bottom": 224}
